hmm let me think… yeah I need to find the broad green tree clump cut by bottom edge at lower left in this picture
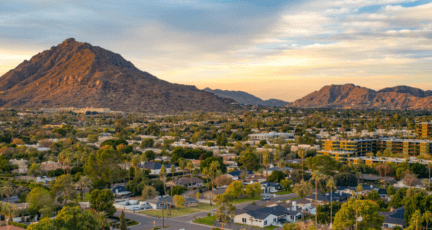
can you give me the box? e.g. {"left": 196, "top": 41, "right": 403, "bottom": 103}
{"left": 27, "top": 206, "right": 102, "bottom": 230}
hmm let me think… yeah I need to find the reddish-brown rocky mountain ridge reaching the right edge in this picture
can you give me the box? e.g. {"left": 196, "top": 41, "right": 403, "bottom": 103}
{"left": 293, "top": 84, "right": 432, "bottom": 109}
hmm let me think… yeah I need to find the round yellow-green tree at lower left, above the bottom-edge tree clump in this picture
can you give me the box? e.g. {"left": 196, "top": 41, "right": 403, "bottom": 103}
{"left": 26, "top": 187, "right": 55, "bottom": 217}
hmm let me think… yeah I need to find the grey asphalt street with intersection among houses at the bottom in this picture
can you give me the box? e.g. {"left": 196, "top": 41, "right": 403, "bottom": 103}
{"left": 115, "top": 193, "right": 297, "bottom": 230}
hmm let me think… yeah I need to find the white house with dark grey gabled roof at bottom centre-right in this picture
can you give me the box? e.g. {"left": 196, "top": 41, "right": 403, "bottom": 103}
{"left": 234, "top": 205, "right": 302, "bottom": 228}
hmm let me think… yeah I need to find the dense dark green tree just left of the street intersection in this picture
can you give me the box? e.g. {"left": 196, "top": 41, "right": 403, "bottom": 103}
{"left": 90, "top": 189, "right": 116, "bottom": 216}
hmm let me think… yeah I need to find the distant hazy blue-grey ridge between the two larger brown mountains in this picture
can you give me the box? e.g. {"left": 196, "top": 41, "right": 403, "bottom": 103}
{"left": 204, "top": 88, "right": 289, "bottom": 107}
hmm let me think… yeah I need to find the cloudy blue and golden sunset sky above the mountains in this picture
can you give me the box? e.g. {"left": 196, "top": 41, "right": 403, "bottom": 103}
{"left": 0, "top": 0, "right": 432, "bottom": 101}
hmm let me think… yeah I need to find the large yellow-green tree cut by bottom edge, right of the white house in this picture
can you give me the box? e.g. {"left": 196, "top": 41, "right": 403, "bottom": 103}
{"left": 333, "top": 199, "right": 384, "bottom": 230}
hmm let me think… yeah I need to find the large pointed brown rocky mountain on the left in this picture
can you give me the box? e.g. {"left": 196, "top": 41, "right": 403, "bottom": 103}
{"left": 0, "top": 38, "right": 227, "bottom": 112}
